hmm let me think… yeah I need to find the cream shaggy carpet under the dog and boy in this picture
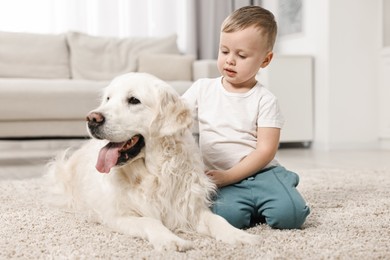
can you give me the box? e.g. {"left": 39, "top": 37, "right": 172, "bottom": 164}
{"left": 0, "top": 169, "right": 390, "bottom": 259}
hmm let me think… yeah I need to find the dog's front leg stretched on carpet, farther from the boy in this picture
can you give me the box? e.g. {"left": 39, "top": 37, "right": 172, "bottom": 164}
{"left": 107, "top": 217, "right": 193, "bottom": 251}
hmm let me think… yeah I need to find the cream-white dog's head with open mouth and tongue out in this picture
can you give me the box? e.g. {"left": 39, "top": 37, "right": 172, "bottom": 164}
{"left": 87, "top": 73, "right": 192, "bottom": 172}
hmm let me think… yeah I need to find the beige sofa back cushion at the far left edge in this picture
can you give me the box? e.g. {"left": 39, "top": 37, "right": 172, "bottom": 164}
{"left": 0, "top": 32, "right": 70, "bottom": 78}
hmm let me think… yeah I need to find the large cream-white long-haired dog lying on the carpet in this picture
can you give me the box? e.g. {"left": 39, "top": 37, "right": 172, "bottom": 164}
{"left": 46, "top": 73, "right": 259, "bottom": 251}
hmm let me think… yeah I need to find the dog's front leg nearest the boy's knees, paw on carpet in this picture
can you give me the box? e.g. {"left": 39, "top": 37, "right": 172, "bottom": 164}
{"left": 198, "top": 210, "right": 260, "bottom": 245}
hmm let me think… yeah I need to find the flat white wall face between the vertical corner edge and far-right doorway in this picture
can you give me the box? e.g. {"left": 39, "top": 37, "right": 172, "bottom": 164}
{"left": 328, "top": 0, "right": 380, "bottom": 148}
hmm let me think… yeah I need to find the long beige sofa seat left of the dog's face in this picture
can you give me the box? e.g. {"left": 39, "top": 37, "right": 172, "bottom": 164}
{"left": 0, "top": 78, "right": 109, "bottom": 122}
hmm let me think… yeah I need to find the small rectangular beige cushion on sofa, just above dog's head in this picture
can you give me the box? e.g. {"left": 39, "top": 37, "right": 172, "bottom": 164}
{"left": 138, "top": 53, "right": 195, "bottom": 81}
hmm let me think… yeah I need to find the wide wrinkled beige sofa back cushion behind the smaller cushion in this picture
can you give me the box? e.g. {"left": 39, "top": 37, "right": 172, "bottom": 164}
{"left": 67, "top": 32, "right": 179, "bottom": 80}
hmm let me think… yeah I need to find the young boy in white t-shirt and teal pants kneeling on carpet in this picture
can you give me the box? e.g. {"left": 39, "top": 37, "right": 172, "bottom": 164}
{"left": 183, "top": 6, "right": 310, "bottom": 229}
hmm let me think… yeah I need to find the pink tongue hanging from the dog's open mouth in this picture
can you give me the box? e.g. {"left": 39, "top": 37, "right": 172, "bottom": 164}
{"left": 96, "top": 143, "right": 124, "bottom": 173}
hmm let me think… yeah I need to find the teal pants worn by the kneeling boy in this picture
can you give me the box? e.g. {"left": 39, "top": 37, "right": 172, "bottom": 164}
{"left": 211, "top": 166, "right": 310, "bottom": 229}
